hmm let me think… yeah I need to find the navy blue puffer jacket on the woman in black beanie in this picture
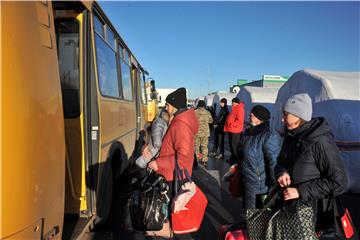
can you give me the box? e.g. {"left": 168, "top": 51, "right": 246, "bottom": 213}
{"left": 239, "top": 122, "right": 281, "bottom": 208}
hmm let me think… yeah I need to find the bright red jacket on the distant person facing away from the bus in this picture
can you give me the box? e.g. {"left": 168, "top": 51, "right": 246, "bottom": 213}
{"left": 224, "top": 102, "right": 244, "bottom": 133}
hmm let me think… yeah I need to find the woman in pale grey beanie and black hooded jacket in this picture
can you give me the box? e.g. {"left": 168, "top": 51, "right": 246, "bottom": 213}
{"left": 275, "top": 93, "right": 348, "bottom": 230}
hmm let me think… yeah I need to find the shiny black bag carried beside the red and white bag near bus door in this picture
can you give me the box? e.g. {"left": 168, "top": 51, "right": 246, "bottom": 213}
{"left": 129, "top": 172, "right": 170, "bottom": 231}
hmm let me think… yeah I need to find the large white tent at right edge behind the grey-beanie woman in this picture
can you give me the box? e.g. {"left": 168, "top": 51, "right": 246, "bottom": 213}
{"left": 273, "top": 69, "right": 360, "bottom": 193}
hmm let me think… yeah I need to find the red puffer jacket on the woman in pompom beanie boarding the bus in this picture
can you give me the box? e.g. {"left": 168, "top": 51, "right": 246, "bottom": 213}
{"left": 156, "top": 109, "right": 199, "bottom": 181}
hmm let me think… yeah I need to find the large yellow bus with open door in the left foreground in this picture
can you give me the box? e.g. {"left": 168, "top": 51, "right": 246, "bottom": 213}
{"left": 0, "top": 1, "right": 148, "bottom": 239}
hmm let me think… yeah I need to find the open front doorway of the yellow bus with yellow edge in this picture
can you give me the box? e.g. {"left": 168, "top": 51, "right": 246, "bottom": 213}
{"left": 54, "top": 4, "right": 98, "bottom": 223}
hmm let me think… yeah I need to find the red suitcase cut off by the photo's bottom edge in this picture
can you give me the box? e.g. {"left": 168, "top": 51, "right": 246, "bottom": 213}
{"left": 219, "top": 223, "right": 249, "bottom": 240}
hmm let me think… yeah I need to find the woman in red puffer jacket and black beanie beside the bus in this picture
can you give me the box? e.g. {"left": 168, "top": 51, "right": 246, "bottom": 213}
{"left": 148, "top": 88, "right": 199, "bottom": 183}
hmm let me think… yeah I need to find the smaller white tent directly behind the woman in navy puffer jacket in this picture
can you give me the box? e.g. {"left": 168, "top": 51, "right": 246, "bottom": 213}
{"left": 236, "top": 86, "right": 279, "bottom": 124}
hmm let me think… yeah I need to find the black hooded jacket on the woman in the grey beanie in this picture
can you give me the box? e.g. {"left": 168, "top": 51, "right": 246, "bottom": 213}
{"left": 275, "top": 118, "right": 348, "bottom": 201}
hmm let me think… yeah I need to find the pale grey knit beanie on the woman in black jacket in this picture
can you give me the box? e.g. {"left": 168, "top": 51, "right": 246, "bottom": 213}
{"left": 284, "top": 93, "right": 312, "bottom": 121}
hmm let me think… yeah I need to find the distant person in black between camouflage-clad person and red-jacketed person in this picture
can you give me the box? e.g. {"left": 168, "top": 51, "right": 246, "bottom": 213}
{"left": 209, "top": 98, "right": 229, "bottom": 159}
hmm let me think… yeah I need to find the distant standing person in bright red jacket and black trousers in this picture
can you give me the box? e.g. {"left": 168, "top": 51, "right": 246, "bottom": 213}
{"left": 224, "top": 98, "right": 244, "bottom": 163}
